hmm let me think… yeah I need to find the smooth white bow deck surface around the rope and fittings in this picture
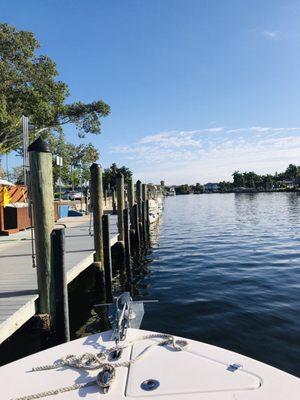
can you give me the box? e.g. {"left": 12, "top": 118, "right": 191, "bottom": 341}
{"left": 0, "top": 329, "right": 300, "bottom": 400}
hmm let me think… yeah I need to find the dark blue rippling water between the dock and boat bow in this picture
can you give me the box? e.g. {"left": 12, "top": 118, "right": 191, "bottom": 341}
{"left": 72, "top": 193, "right": 300, "bottom": 376}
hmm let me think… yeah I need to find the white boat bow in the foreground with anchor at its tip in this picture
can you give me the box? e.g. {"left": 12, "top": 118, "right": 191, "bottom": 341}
{"left": 0, "top": 293, "right": 300, "bottom": 400}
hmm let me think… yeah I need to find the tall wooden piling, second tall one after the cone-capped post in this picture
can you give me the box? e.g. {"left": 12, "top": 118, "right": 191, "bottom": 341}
{"left": 90, "top": 163, "right": 103, "bottom": 270}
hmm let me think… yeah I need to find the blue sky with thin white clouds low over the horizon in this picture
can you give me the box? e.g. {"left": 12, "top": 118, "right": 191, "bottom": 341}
{"left": 0, "top": 0, "right": 300, "bottom": 184}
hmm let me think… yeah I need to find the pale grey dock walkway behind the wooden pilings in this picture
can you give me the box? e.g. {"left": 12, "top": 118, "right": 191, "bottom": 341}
{"left": 0, "top": 216, "right": 117, "bottom": 344}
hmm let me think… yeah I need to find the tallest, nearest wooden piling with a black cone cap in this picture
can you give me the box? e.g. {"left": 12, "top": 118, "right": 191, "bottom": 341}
{"left": 28, "top": 137, "right": 54, "bottom": 322}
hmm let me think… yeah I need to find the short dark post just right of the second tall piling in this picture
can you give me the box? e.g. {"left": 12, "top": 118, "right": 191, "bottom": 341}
{"left": 102, "top": 214, "right": 112, "bottom": 302}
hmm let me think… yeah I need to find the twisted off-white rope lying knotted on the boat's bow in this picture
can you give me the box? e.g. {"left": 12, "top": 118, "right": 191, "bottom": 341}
{"left": 11, "top": 333, "right": 188, "bottom": 400}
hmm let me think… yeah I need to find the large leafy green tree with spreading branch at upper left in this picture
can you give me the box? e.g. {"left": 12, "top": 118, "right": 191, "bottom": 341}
{"left": 0, "top": 23, "right": 110, "bottom": 154}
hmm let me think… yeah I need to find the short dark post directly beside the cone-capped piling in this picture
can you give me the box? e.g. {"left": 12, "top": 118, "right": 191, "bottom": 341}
{"left": 51, "top": 228, "right": 70, "bottom": 344}
